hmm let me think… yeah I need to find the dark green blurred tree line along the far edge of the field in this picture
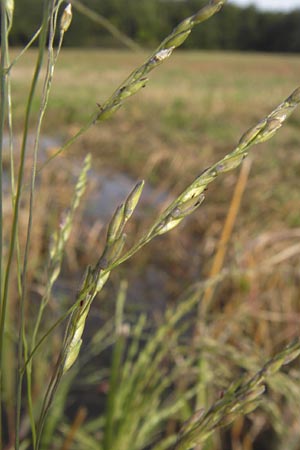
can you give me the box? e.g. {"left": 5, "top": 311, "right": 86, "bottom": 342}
{"left": 11, "top": 0, "right": 300, "bottom": 52}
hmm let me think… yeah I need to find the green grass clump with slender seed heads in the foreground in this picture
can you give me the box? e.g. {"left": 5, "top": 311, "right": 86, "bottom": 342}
{"left": 0, "top": 0, "right": 300, "bottom": 450}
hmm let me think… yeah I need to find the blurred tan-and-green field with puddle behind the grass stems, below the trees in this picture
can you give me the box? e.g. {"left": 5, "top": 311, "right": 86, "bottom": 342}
{"left": 4, "top": 1, "right": 300, "bottom": 450}
